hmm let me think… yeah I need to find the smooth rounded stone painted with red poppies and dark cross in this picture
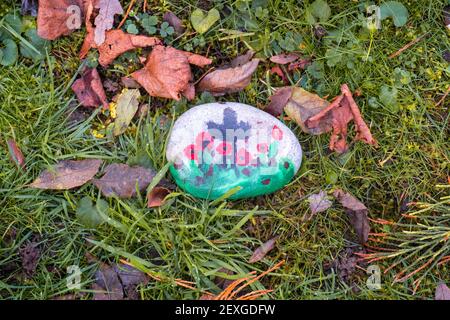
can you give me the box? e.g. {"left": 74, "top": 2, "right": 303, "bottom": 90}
{"left": 166, "top": 102, "right": 302, "bottom": 199}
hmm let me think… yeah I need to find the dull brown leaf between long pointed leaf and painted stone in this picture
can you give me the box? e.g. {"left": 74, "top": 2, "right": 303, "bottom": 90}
{"left": 92, "top": 163, "right": 156, "bottom": 198}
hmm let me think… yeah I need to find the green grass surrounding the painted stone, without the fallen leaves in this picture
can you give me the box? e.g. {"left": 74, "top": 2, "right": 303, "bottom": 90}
{"left": 0, "top": 0, "right": 450, "bottom": 299}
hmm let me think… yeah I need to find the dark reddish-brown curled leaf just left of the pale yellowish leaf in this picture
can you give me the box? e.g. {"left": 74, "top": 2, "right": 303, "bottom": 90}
{"left": 72, "top": 68, "right": 108, "bottom": 109}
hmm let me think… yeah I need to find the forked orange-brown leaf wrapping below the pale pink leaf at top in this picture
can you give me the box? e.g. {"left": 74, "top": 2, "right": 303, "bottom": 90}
{"left": 79, "top": 0, "right": 161, "bottom": 67}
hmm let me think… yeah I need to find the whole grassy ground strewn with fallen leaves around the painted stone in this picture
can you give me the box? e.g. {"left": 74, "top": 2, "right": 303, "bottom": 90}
{"left": 0, "top": 0, "right": 450, "bottom": 299}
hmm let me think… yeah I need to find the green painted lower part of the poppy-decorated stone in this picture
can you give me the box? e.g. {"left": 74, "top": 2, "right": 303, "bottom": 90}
{"left": 170, "top": 159, "right": 295, "bottom": 200}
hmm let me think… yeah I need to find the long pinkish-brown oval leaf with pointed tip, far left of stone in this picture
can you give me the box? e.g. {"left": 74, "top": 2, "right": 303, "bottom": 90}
{"left": 29, "top": 159, "right": 102, "bottom": 190}
